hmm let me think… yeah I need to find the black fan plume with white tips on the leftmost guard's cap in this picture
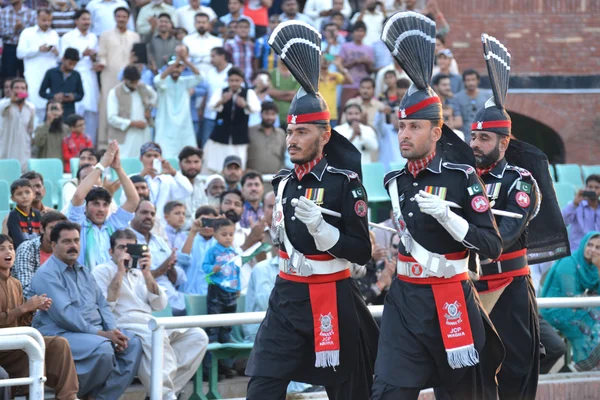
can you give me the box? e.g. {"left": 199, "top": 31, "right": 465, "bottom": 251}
{"left": 269, "top": 20, "right": 321, "bottom": 93}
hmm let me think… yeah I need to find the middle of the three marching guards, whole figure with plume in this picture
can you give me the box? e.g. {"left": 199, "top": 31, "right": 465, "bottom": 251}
{"left": 372, "top": 12, "right": 503, "bottom": 400}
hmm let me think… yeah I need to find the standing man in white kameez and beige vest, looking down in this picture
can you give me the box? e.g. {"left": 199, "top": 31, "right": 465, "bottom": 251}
{"left": 106, "top": 65, "right": 157, "bottom": 157}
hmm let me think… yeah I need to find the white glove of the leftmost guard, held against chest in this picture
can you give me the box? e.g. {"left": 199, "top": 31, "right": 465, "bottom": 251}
{"left": 294, "top": 196, "right": 340, "bottom": 251}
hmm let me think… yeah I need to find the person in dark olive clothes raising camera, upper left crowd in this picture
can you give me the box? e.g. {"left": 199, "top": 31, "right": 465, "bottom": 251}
{"left": 32, "top": 100, "right": 69, "bottom": 160}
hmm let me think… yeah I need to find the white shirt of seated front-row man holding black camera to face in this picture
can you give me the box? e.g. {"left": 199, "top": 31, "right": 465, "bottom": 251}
{"left": 92, "top": 260, "right": 168, "bottom": 328}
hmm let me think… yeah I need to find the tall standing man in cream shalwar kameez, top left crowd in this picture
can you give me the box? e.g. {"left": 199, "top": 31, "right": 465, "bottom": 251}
{"left": 92, "top": 5, "right": 140, "bottom": 150}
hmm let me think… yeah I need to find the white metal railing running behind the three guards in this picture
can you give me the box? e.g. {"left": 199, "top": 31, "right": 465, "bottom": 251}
{"left": 148, "top": 296, "right": 600, "bottom": 400}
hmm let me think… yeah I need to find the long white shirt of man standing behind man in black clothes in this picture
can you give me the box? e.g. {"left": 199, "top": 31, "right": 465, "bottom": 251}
{"left": 60, "top": 28, "right": 100, "bottom": 113}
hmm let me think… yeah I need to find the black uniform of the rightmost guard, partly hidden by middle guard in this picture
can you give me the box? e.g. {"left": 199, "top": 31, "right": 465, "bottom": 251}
{"left": 474, "top": 159, "right": 541, "bottom": 400}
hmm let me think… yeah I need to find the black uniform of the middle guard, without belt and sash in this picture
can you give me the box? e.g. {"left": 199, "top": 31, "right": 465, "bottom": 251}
{"left": 372, "top": 150, "right": 502, "bottom": 399}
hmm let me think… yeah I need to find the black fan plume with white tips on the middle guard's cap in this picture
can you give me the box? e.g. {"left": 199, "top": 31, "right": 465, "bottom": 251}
{"left": 381, "top": 11, "right": 435, "bottom": 90}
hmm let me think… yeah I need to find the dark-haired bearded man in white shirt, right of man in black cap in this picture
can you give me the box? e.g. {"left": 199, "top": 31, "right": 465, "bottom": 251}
{"left": 177, "top": 146, "right": 208, "bottom": 223}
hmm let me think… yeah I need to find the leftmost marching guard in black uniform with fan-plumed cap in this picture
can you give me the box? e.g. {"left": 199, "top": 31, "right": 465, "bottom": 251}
{"left": 246, "top": 21, "right": 377, "bottom": 400}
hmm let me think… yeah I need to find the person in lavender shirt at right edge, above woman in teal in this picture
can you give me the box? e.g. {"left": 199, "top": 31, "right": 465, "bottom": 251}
{"left": 562, "top": 174, "right": 600, "bottom": 252}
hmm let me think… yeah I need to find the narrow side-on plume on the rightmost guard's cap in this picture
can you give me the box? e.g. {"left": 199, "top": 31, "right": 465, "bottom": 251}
{"left": 481, "top": 33, "right": 510, "bottom": 109}
